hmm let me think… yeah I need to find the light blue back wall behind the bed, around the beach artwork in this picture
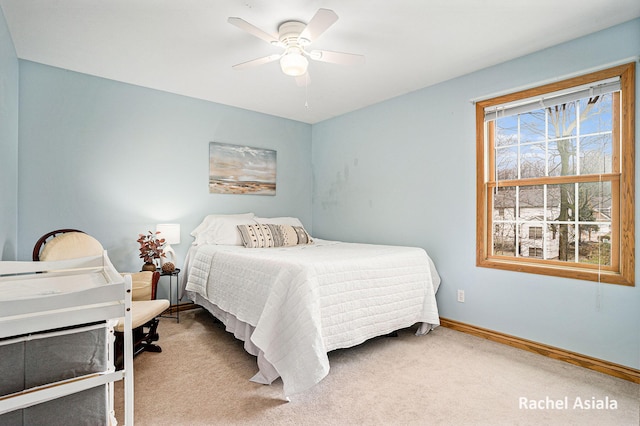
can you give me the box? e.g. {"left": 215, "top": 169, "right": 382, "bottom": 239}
{"left": 18, "top": 61, "right": 312, "bottom": 282}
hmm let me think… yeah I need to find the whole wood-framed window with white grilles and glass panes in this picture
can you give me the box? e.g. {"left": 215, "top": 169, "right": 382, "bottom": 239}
{"left": 476, "top": 63, "right": 635, "bottom": 285}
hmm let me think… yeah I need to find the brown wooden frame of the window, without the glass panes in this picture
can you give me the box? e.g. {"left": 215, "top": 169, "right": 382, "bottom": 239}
{"left": 476, "top": 63, "right": 636, "bottom": 286}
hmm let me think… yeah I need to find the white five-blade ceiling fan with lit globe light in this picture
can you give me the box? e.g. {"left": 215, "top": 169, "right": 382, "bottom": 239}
{"left": 227, "top": 9, "right": 364, "bottom": 84}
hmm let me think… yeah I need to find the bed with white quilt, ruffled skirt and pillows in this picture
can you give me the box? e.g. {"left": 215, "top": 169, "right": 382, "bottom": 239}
{"left": 182, "top": 213, "right": 440, "bottom": 398}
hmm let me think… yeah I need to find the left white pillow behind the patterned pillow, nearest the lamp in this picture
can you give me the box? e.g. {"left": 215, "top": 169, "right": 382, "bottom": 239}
{"left": 191, "top": 213, "right": 255, "bottom": 246}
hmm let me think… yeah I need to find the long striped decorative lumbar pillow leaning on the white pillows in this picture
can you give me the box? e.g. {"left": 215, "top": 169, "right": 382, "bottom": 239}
{"left": 238, "top": 224, "right": 313, "bottom": 248}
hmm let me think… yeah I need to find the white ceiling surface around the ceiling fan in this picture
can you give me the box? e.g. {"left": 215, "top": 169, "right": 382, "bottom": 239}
{"left": 0, "top": 0, "right": 640, "bottom": 123}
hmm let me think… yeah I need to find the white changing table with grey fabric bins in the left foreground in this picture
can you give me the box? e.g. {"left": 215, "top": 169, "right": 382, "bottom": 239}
{"left": 0, "top": 253, "right": 133, "bottom": 426}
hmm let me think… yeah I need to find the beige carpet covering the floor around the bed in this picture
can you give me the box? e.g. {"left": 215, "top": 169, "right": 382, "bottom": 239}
{"left": 116, "top": 309, "right": 640, "bottom": 426}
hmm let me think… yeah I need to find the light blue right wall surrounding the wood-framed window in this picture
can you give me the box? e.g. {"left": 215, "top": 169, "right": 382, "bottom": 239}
{"left": 312, "top": 20, "right": 640, "bottom": 368}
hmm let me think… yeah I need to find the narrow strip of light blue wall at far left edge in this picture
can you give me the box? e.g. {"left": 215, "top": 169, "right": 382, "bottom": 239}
{"left": 0, "top": 5, "right": 19, "bottom": 260}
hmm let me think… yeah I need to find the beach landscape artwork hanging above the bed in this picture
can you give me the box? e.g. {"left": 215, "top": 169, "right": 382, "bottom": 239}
{"left": 209, "top": 142, "right": 276, "bottom": 195}
